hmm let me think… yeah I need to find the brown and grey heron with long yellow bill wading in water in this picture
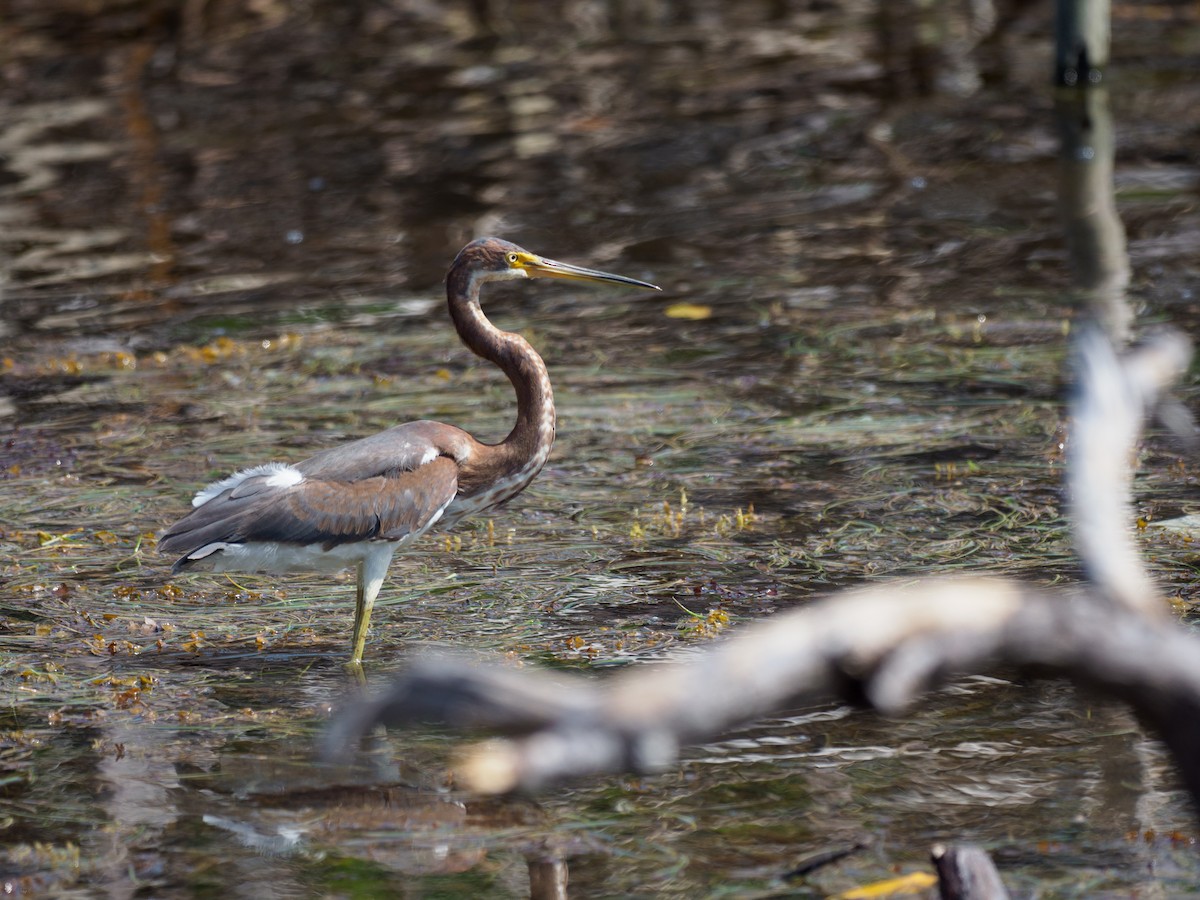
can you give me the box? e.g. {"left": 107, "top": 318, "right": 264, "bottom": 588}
{"left": 158, "top": 238, "right": 660, "bottom": 668}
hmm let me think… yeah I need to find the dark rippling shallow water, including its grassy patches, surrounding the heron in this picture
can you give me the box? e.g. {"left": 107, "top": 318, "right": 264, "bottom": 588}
{"left": 0, "top": 2, "right": 1200, "bottom": 896}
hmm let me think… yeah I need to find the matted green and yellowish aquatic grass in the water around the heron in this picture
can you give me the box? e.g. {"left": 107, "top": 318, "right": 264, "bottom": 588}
{"left": 7, "top": 294, "right": 1196, "bottom": 893}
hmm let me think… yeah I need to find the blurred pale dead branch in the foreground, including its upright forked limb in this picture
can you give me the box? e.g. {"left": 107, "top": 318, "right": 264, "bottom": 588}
{"left": 326, "top": 331, "right": 1200, "bottom": 805}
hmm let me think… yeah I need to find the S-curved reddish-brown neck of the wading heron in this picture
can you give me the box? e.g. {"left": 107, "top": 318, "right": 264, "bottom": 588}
{"left": 446, "top": 268, "right": 554, "bottom": 465}
